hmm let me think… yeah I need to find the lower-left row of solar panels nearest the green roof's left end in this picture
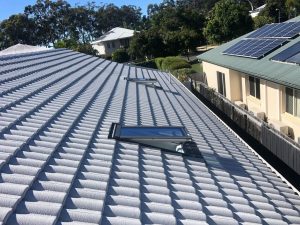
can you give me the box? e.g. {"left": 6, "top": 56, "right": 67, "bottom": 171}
{"left": 223, "top": 39, "right": 286, "bottom": 59}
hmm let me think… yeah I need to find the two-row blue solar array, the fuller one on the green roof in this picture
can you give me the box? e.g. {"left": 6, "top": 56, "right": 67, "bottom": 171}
{"left": 223, "top": 22, "right": 300, "bottom": 61}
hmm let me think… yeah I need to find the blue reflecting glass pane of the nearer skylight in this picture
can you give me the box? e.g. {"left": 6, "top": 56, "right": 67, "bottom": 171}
{"left": 120, "top": 127, "right": 186, "bottom": 137}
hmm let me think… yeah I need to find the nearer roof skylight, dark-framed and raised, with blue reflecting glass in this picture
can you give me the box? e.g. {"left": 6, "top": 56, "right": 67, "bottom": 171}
{"left": 108, "top": 123, "right": 201, "bottom": 157}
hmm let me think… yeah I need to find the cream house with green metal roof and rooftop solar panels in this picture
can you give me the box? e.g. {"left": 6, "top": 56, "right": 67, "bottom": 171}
{"left": 198, "top": 17, "right": 300, "bottom": 142}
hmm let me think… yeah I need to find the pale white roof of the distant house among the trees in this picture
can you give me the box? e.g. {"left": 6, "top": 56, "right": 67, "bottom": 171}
{"left": 92, "top": 27, "right": 134, "bottom": 44}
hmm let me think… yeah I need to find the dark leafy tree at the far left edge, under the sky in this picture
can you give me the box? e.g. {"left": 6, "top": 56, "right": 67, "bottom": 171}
{"left": 0, "top": 14, "right": 38, "bottom": 49}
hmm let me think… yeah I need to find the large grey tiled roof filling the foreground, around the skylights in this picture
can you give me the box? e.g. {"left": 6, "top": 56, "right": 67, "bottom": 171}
{"left": 0, "top": 50, "right": 300, "bottom": 225}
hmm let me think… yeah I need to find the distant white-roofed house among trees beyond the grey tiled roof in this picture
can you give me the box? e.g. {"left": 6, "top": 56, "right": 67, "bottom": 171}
{"left": 91, "top": 27, "right": 135, "bottom": 57}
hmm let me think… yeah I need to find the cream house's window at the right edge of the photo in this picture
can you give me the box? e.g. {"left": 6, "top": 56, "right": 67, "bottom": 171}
{"left": 285, "top": 88, "right": 300, "bottom": 117}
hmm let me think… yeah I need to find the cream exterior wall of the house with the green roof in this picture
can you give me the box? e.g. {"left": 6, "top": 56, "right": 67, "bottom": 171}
{"left": 203, "top": 62, "right": 300, "bottom": 141}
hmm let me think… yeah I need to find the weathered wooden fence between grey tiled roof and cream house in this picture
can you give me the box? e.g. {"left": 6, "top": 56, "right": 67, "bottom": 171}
{"left": 192, "top": 81, "right": 300, "bottom": 175}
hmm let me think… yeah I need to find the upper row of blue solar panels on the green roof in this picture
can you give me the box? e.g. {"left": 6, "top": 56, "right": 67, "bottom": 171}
{"left": 247, "top": 22, "right": 300, "bottom": 39}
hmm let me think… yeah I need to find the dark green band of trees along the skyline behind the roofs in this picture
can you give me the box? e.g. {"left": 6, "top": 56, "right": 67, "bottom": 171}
{"left": 0, "top": 0, "right": 300, "bottom": 59}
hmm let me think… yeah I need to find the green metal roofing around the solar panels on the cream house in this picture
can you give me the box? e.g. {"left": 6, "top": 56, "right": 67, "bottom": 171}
{"left": 198, "top": 16, "right": 300, "bottom": 89}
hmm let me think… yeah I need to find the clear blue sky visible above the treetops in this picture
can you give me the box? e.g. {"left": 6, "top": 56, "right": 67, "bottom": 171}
{"left": 0, "top": 0, "right": 162, "bottom": 20}
